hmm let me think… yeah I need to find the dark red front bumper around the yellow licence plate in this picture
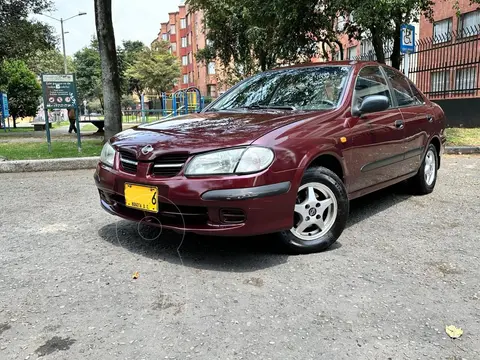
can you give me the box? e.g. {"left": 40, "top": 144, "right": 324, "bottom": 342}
{"left": 94, "top": 164, "right": 296, "bottom": 236}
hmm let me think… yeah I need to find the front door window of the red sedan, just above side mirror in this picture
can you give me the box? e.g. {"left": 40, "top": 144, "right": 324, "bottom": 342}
{"left": 353, "top": 66, "right": 392, "bottom": 107}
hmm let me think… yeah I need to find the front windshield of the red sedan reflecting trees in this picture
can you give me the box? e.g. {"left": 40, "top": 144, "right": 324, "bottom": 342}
{"left": 209, "top": 66, "right": 350, "bottom": 111}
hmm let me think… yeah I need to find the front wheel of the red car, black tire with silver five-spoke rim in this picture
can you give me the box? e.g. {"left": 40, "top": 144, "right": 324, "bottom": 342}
{"left": 279, "top": 167, "right": 349, "bottom": 254}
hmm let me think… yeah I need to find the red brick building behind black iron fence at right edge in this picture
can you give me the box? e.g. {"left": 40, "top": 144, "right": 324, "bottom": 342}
{"left": 413, "top": 0, "right": 480, "bottom": 99}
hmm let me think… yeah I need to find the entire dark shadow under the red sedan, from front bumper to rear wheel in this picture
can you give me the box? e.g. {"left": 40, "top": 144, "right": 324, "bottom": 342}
{"left": 98, "top": 184, "right": 410, "bottom": 272}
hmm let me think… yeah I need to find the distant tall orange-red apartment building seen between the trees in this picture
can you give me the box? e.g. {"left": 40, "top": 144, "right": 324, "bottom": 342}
{"left": 156, "top": 5, "right": 218, "bottom": 98}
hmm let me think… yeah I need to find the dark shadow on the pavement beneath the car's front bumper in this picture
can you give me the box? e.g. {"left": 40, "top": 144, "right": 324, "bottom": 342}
{"left": 98, "top": 220, "right": 288, "bottom": 272}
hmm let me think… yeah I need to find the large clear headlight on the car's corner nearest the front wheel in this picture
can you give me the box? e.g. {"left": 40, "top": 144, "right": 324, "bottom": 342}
{"left": 185, "top": 146, "right": 275, "bottom": 176}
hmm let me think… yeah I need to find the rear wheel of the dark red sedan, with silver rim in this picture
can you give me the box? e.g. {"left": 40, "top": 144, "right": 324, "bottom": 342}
{"left": 410, "top": 144, "right": 439, "bottom": 195}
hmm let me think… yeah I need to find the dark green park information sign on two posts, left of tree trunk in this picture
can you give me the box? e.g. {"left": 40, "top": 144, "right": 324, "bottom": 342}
{"left": 42, "top": 74, "right": 82, "bottom": 152}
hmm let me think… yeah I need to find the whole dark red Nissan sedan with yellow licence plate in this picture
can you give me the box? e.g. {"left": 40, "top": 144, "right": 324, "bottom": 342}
{"left": 95, "top": 62, "right": 445, "bottom": 253}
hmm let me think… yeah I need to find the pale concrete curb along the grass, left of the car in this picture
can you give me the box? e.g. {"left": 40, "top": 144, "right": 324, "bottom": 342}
{"left": 0, "top": 156, "right": 99, "bottom": 174}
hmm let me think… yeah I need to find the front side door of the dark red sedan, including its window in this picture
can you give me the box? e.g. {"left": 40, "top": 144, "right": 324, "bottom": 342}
{"left": 348, "top": 66, "right": 405, "bottom": 193}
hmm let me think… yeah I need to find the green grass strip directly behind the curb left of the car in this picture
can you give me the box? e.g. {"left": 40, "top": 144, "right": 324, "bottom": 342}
{"left": 0, "top": 140, "right": 103, "bottom": 160}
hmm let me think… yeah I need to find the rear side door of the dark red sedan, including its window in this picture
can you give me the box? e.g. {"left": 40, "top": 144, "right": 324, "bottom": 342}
{"left": 383, "top": 66, "right": 433, "bottom": 174}
